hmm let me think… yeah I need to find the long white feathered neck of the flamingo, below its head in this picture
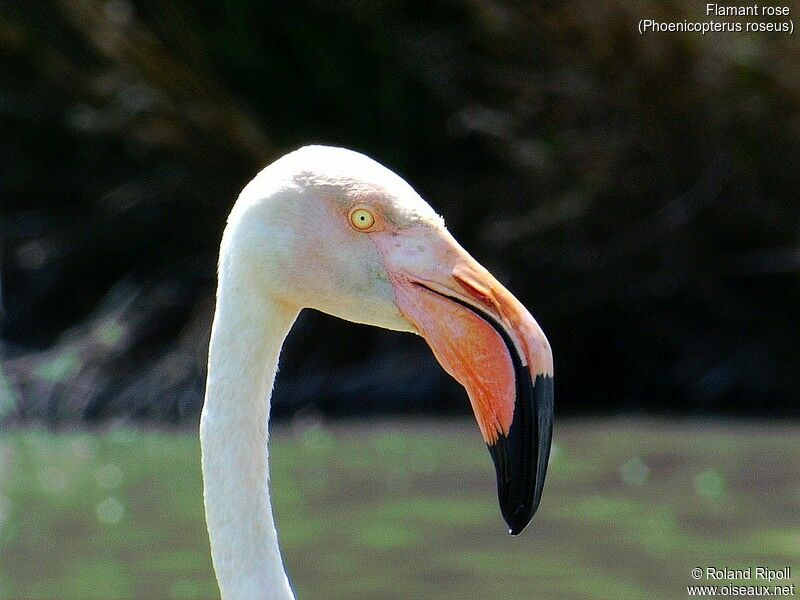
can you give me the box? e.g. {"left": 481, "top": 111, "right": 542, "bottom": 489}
{"left": 200, "top": 264, "right": 297, "bottom": 600}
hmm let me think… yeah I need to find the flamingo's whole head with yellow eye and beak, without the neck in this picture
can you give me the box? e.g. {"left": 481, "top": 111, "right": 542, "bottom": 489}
{"left": 234, "top": 146, "right": 553, "bottom": 534}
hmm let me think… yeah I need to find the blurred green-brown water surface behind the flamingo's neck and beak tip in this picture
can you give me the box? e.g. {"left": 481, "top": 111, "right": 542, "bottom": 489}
{"left": 0, "top": 421, "right": 800, "bottom": 600}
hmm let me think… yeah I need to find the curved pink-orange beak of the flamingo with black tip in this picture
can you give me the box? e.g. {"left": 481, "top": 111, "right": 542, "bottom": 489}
{"left": 387, "top": 230, "right": 553, "bottom": 535}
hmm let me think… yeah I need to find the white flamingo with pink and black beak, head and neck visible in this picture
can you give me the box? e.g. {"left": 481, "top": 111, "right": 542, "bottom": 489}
{"left": 200, "top": 146, "right": 553, "bottom": 600}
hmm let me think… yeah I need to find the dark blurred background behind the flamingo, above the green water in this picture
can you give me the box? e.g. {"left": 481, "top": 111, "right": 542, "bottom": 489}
{"left": 0, "top": 0, "right": 800, "bottom": 423}
